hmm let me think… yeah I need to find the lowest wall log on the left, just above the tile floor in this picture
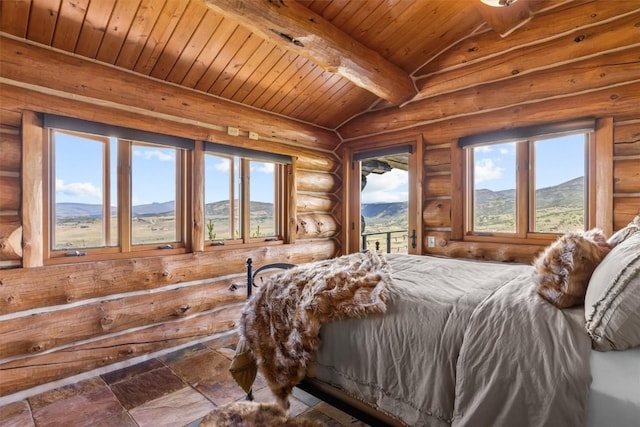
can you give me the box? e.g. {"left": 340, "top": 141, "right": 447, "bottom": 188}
{"left": 0, "top": 304, "right": 243, "bottom": 396}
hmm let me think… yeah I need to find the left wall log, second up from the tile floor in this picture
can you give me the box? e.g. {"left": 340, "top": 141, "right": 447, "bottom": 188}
{"left": 0, "top": 274, "right": 246, "bottom": 359}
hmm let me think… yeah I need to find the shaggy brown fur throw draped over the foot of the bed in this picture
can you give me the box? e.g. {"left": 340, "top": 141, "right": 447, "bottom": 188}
{"left": 239, "top": 252, "right": 391, "bottom": 409}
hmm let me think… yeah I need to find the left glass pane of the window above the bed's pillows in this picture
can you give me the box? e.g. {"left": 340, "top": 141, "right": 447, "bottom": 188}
{"left": 473, "top": 143, "right": 516, "bottom": 233}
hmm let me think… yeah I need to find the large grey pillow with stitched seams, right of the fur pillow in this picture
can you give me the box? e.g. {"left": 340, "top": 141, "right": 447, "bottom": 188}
{"left": 584, "top": 233, "right": 640, "bottom": 351}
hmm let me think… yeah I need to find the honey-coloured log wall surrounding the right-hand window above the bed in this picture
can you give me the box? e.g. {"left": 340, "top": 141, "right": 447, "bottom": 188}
{"left": 338, "top": 2, "right": 640, "bottom": 263}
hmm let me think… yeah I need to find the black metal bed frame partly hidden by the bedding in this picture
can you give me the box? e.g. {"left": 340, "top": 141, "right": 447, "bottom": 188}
{"left": 247, "top": 258, "right": 397, "bottom": 427}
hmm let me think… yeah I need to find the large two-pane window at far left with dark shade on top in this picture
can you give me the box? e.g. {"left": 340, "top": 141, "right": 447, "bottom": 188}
{"left": 45, "top": 115, "right": 193, "bottom": 259}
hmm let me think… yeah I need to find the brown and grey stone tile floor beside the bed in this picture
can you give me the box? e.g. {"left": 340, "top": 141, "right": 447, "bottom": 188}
{"left": 0, "top": 343, "right": 366, "bottom": 427}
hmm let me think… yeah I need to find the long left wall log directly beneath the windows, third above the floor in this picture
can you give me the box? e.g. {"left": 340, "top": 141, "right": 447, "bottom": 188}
{"left": 0, "top": 240, "right": 338, "bottom": 315}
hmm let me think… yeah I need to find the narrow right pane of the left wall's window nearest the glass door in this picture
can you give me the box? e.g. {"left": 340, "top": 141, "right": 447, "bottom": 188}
{"left": 249, "top": 161, "right": 277, "bottom": 238}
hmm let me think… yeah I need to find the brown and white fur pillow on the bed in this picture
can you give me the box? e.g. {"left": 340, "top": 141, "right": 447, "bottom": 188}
{"left": 533, "top": 228, "right": 611, "bottom": 308}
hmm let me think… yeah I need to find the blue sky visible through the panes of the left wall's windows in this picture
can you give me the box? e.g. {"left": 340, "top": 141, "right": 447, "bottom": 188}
{"left": 55, "top": 134, "right": 273, "bottom": 205}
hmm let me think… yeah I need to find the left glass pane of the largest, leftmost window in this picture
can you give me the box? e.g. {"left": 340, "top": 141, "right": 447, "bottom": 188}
{"left": 51, "top": 131, "right": 110, "bottom": 250}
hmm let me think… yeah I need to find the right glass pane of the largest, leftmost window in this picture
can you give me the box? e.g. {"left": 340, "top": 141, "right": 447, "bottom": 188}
{"left": 131, "top": 144, "right": 180, "bottom": 245}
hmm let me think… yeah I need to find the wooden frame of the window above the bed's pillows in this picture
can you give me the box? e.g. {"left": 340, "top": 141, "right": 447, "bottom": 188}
{"left": 454, "top": 119, "right": 596, "bottom": 245}
